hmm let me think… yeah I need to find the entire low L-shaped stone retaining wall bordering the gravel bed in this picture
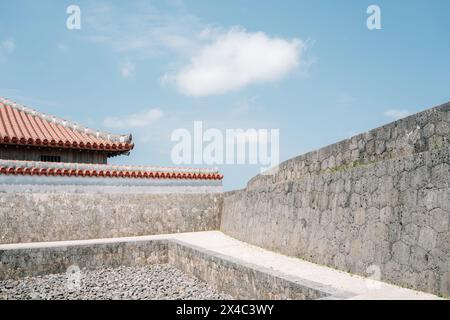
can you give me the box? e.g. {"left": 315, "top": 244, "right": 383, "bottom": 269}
{"left": 0, "top": 239, "right": 355, "bottom": 300}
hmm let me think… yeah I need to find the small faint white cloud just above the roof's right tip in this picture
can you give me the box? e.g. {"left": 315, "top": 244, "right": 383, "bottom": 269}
{"left": 103, "top": 108, "right": 164, "bottom": 129}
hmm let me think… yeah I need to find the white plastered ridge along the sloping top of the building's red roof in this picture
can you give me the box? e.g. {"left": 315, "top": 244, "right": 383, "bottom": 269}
{"left": 0, "top": 96, "right": 132, "bottom": 143}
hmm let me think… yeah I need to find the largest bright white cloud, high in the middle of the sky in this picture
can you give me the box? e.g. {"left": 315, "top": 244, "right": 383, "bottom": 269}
{"left": 163, "top": 27, "right": 305, "bottom": 96}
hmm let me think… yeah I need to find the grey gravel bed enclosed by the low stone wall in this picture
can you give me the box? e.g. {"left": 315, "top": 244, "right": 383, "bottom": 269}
{"left": 0, "top": 264, "right": 232, "bottom": 300}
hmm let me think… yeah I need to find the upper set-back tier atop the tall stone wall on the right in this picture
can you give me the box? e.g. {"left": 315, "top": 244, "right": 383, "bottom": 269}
{"left": 247, "top": 102, "right": 450, "bottom": 189}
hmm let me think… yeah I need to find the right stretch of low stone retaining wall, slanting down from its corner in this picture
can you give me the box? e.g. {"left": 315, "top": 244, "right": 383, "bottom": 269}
{"left": 168, "top": 240, "right": 354, "bottom": 300}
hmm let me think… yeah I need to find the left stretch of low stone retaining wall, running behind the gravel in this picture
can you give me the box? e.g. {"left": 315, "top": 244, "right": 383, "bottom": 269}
{"left": 0, "top": 240, "right": 168, "bottom": 280}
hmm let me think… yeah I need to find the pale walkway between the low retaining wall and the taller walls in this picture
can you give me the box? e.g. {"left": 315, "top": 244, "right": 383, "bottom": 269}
{"left": 0, "top": 231, "right": 439, "bottom": 300}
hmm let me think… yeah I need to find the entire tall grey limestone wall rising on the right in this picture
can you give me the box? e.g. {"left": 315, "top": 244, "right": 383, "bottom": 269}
{"left": 221, "top": 104, "right": 450, "bottom": 296}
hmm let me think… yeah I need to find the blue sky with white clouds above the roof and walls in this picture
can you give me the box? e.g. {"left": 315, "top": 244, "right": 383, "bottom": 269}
{"left": 0, "top": 0, "right": 450, "bottom": 190}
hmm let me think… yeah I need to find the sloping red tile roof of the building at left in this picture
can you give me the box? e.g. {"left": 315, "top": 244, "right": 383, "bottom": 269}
{"left": 0, "top": 97, "right": 134, "bottom": 153}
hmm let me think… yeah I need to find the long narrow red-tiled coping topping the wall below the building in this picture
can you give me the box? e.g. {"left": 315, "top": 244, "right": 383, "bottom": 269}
{"left": 0, "top": 160, "right": 223, "bottom": 180}
